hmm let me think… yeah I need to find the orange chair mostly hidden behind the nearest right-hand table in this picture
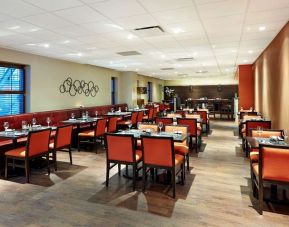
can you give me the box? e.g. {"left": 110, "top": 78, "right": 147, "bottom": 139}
{"left": 249, "top": 129, "right": 283, "bottom": 163}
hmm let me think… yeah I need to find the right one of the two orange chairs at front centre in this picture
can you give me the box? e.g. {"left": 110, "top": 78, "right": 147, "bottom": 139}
{"left": 141, "top": 136, "right": 184, "bottom": 198}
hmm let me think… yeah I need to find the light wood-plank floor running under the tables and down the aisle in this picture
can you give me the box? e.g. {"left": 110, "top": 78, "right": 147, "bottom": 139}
{"left": 0, "top": 121, "right": 289, "bottom": 226}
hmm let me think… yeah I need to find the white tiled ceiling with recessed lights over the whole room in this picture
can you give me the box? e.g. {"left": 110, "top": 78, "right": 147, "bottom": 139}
{"left": 0, "top": 0, "right": 289, "bottom": 79}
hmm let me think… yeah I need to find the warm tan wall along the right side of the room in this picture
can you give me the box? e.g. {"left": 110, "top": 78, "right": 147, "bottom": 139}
{"left": 254, "top": 23, "right": 289, "bottom": 129}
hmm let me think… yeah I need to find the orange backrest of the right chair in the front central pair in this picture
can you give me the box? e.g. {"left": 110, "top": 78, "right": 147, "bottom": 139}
{"left": 141, "top": 136, "right": 175, "bottom": 167}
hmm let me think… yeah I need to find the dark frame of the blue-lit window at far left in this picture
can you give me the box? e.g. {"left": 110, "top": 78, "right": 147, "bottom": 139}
{"left": 0, "top": 61, "right": 26, "bottom": 117}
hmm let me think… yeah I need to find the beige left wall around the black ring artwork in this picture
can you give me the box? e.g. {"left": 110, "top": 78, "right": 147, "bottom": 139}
{"left": 0, "top": 48, "right": 163, "bottom": 112}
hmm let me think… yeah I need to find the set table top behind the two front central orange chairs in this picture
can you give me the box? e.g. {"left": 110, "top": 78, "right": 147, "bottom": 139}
{"left": 117, "top": 129, "right": 189, "bottom": 142}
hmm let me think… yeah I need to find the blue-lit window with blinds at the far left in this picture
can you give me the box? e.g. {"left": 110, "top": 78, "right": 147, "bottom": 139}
{"left": 0, "top": 63, "right": 25, "bottom": 116}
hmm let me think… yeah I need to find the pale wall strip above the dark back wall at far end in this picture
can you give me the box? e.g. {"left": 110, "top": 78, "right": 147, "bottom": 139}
{"left": 165, "top": 76, "right": 238, "bottom": 86}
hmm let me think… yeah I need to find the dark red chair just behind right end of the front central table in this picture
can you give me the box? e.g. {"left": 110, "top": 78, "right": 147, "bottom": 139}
{"left": 177, "top": 118, "right": 202, "bottom": 152}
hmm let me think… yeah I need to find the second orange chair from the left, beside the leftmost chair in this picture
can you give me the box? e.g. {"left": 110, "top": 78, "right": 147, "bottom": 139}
{"left": 49, "top": 125, "right": 73, "bottom": 170}
